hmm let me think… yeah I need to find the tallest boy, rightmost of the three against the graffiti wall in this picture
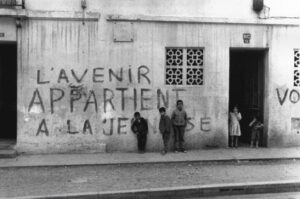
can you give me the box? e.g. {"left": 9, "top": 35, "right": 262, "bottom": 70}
{"left": 171, "top": 100, "right": 187, "bottom": 153}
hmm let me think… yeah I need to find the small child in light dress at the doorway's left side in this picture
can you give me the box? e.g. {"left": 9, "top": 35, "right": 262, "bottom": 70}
{"left": 229, "top": 106, "right": 242, "bottom": 148}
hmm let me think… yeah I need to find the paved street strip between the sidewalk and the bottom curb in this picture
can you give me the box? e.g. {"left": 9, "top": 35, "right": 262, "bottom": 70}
{"left": 0, "top": 161, "right": 300, "bottom": 197}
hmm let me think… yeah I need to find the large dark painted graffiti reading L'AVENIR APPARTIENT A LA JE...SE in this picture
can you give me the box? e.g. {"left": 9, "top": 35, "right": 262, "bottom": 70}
{"left": 28, "top": 65, "right": 211, "bottom": 136}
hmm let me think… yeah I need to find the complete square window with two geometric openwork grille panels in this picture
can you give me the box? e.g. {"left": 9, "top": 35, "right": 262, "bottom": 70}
{"left": 166, "top": 47, "right": 204, "bottom": 85}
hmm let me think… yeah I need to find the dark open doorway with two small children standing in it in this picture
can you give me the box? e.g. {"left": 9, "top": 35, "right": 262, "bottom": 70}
{"left": 229, "top": 49, "right": 267, "bottom": 146}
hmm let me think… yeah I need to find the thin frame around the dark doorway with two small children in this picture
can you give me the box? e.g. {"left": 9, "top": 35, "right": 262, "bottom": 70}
{"left": 227, "top": 47, "right": 270, "bottom": 147}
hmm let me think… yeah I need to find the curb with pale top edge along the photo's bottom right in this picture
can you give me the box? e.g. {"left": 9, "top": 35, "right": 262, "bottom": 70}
{"left": 9, "top": 181, "right": 300, "bottom": 199}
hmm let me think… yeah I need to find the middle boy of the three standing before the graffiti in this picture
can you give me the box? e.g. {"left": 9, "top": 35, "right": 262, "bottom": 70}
{"left": 159, "top": 107, "right": 171, "bottom": 155}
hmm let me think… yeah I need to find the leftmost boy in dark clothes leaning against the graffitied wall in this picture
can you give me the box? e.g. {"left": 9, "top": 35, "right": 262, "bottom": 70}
{"left": 131, "top": 112, "right": 148, "bottom": 153}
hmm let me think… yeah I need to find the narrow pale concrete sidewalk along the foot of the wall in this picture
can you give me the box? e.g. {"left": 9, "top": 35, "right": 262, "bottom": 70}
{"left": 0, "top": 148, "right": 300, "bottom": 168}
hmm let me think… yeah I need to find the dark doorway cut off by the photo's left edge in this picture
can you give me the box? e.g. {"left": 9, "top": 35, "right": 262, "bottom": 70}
{"left": 0, "top": 42, "right": 17, "bottom": 144}
